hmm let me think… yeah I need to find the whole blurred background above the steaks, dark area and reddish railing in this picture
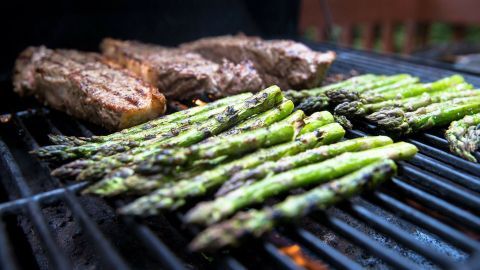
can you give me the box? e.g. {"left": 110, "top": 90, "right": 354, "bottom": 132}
{"left": 0, "top": 0, "right": 480, "bottom": 74}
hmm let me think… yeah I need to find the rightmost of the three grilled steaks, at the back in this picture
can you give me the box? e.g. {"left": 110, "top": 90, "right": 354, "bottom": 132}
{"left": 181, "top": 35, "right": 335, "bottom": 89}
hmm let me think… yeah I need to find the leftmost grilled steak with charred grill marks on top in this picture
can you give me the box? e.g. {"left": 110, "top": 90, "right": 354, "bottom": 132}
{"left": 13, "top": 47, "right": 166, "bottom": 129}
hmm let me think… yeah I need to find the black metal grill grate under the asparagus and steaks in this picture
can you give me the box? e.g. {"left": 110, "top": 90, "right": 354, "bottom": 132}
{"left": 0, "top": 44, "right": 480, "bottom": 269}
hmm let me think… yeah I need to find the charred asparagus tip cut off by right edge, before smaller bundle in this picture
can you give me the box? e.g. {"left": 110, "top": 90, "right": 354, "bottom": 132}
{"left": 445, "top": 113, "right": 480, "bottom": 162}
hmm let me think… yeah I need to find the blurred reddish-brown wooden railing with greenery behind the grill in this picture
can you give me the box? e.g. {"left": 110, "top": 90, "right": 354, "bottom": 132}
{"left": 299, "top": 0, "right": 480, "bottom": 72}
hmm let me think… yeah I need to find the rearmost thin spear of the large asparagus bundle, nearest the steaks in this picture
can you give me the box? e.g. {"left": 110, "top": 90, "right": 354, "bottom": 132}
{"left": 49, "top": 93, "right": 252, "bottom": 145}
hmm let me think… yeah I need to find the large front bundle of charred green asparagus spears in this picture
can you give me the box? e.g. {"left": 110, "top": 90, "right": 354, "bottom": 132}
{"left": 35, "top": 86, "right": 417, "bottom": 250}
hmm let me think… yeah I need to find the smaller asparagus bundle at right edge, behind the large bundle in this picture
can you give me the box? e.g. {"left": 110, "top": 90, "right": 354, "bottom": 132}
{"left": 287, "top": 74, "right": 480, "bottom": 161}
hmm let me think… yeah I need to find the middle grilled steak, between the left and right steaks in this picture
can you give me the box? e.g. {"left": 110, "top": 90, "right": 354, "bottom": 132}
{"left": 101, "top": 38, "right": 265, "bottom": 100}
